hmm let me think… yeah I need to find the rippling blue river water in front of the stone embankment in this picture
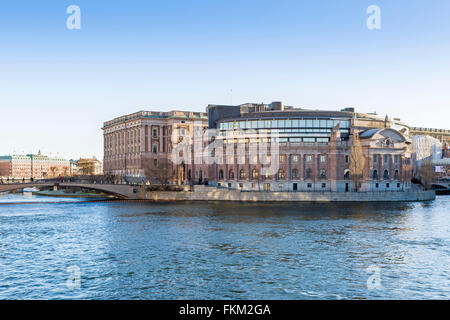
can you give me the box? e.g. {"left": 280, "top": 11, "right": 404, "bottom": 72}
{"left": 0, "top": 195, "right": 450, "bottom": 299}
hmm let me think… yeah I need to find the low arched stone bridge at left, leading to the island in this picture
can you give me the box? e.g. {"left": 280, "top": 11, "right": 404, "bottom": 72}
{"left": 0, "top": 182, "right": 145, "bottom": 199}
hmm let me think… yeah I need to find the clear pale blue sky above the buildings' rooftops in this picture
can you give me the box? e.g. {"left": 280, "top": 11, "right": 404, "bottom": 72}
{"left": 0, "top": 0, "right": 450, "bottom": 158}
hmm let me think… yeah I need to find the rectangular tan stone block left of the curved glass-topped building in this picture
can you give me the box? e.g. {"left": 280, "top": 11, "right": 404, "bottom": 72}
{"left": 103, "top": 111, "right": 207, "bottom": 183}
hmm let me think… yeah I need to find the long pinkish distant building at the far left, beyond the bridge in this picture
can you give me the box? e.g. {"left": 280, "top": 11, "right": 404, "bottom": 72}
{"left": 0, "top": 152, "right": 70, "bottom": 179}
